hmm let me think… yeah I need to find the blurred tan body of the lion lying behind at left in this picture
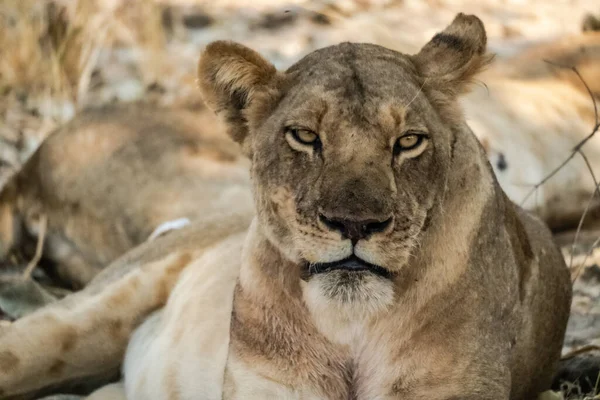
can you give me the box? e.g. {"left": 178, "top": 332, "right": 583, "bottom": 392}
{"left": 0, "top": 105, "right": 251, "bottom": 287}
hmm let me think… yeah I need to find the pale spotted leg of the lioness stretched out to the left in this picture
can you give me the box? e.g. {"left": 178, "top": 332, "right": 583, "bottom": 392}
{"left": 0, "top": 252, "right": 192, "bottom": 397}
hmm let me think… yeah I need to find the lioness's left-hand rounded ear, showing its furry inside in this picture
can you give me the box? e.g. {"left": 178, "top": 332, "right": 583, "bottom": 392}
{"left": 198, "top": 41, "right": 278, "bottom": 148}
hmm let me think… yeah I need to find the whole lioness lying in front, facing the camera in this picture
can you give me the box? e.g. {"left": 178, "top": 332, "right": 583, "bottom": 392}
{"left": 0, "top": 14, "right": 571, "bottom": 400}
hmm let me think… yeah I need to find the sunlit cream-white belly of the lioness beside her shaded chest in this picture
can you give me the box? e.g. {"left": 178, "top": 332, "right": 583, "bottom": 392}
{"left": 123, "top": 233, "right": 246, "bottom": 400}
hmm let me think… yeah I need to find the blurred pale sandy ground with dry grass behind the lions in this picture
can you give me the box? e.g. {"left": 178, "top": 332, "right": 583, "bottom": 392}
{"left": 0, "top": 0, "right": 600, "bottom": 398}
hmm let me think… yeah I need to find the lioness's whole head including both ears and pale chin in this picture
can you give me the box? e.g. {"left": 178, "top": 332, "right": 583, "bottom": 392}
{"left": 199, "top": 14, "right": 490, "bottom": 312}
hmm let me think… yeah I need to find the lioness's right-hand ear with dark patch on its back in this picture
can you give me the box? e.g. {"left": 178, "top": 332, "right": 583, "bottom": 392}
{"left": 412, "top": 13, "right": 493, "bottom": 97}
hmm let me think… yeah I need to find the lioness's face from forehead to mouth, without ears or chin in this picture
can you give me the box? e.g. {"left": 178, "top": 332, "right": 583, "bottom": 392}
{"left": 251, "top": 44, "right": 452, "bottom": 275}
